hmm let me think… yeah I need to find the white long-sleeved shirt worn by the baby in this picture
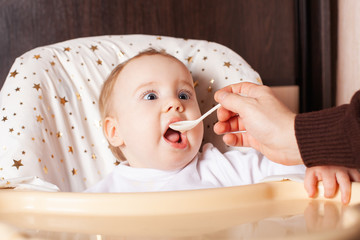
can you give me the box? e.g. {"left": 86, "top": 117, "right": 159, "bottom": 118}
{"left": 86, "top": 143, "right": 306, "bottom": 192}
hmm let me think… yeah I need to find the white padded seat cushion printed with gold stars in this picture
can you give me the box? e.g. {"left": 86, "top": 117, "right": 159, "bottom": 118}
{"left": 0, "top": 35, "right": 261, "bottom": 191}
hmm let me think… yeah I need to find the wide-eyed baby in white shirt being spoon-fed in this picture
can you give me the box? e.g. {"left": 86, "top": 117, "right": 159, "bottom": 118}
{"left": 87, "top": 49, "right": 360, "bottom": 204}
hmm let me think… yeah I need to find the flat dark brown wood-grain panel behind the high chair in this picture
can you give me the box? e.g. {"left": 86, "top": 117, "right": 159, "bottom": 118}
{"left": 0, "top": 0, "right": 298, "bottom": 89}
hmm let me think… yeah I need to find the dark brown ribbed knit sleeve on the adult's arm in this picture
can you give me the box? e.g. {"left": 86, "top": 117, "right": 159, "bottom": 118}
{"left": 295, "top": 91, "right": 360, "bottom": 168}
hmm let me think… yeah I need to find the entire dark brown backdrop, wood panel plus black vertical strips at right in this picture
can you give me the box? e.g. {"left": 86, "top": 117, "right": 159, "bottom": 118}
{"left": 0, "top": 0, "right": 337, "bottom": 111}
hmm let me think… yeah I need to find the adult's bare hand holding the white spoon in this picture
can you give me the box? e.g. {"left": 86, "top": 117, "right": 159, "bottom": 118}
{"left": 214, "top": 82, "right": 303, "bottom": 165}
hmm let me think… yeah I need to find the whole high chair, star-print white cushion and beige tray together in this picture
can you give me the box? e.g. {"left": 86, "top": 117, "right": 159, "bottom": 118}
{"left": 0, "top": 35, "right": 360, "bottom": 239}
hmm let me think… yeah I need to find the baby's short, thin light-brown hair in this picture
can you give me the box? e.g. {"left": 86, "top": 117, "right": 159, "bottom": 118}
{"left": 99, "top": 48, "right": 179, "bottom": 161}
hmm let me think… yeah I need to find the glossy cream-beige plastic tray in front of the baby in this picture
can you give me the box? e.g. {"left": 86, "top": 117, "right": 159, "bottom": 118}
{"left": 0, "top": 181, "right": 360, "bottom": 240}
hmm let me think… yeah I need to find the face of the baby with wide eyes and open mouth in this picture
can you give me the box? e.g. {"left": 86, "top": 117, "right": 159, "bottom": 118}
{"left": 107, "top": 55, "right": 203, "bottom": 170}
